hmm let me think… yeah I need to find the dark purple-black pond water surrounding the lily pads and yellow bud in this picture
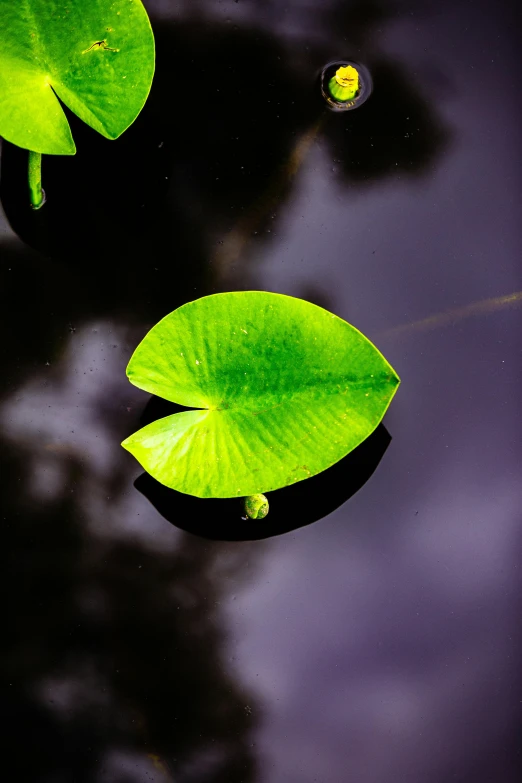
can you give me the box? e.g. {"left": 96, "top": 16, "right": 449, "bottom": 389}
{"left": 0, "top": 0, "right": 522, "bottom": 783}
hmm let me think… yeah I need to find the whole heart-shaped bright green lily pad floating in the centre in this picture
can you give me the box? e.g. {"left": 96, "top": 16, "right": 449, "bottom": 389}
{"left": 122, "top": 291, "right": 400, "bottom": 497}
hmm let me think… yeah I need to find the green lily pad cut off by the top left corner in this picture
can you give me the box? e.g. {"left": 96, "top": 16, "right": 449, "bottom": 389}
{"left": 0, "top": 0, "right": 154, "bottom": 155}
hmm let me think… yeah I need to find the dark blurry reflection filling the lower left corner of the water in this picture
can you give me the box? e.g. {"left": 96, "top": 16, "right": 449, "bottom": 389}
{"left": 0, "top": 449, "right": 259, "bottom": 783}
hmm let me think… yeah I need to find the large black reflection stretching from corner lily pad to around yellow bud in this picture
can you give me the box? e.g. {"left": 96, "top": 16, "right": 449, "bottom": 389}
{"left": 0, "top": 10, "right": 447, "bottom": 302}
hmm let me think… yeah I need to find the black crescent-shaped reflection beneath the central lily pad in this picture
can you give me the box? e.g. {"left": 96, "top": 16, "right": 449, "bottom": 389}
{"left": 134, "top": 414, "right": 391, "bottom": 541}
